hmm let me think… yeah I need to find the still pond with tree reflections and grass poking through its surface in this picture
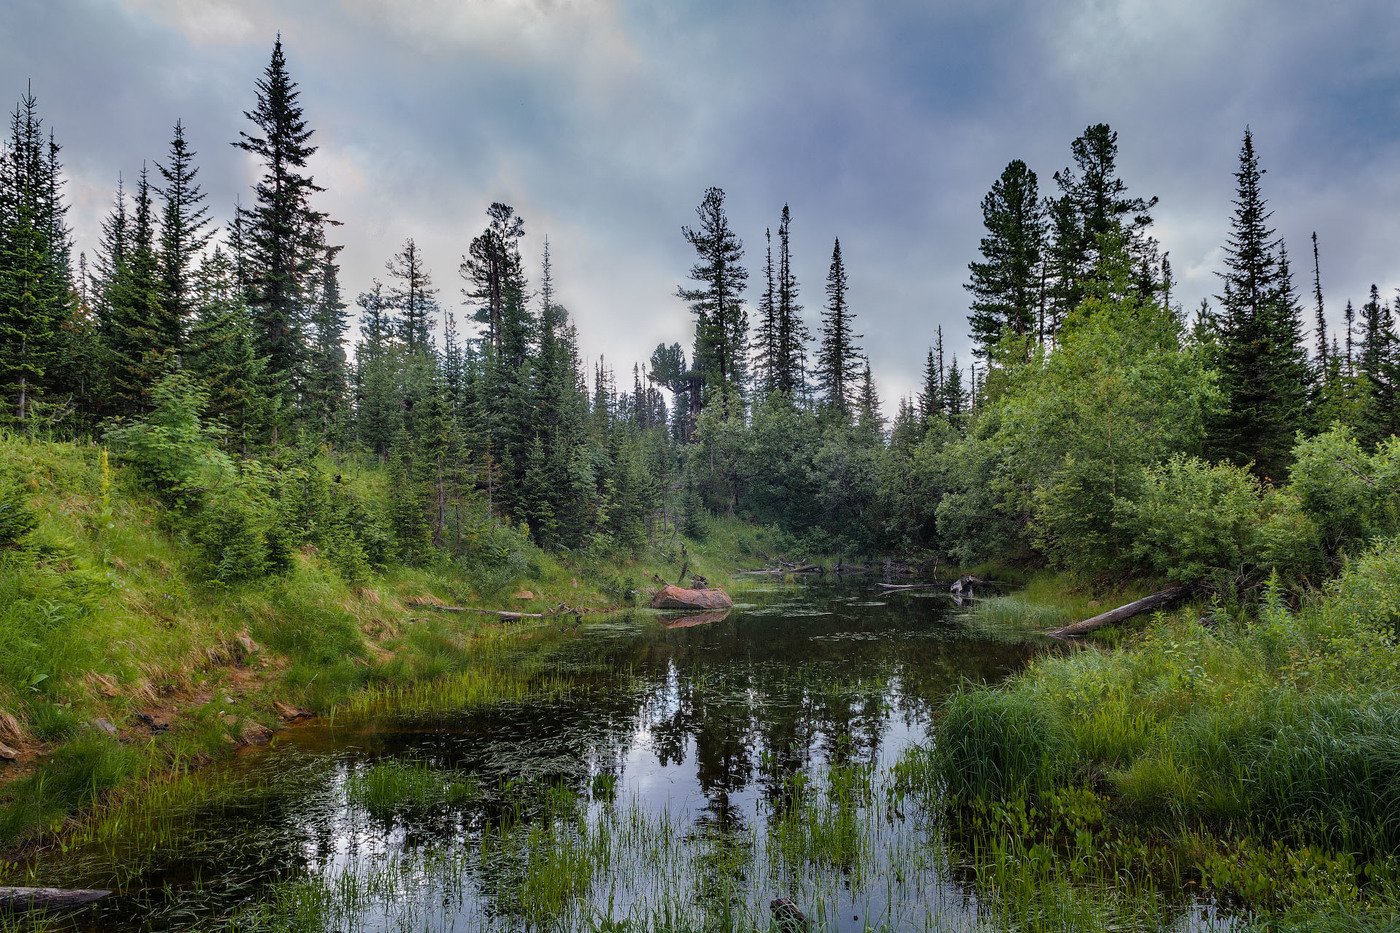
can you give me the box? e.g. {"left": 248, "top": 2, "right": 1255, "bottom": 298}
{"left": 2, "top": 581, "right": 1237, "bottom": 930}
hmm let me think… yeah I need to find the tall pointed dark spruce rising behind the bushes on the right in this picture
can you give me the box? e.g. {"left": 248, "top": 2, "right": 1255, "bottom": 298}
{"left": 1214, "top": 129, "right": 1309, "bottom": 481}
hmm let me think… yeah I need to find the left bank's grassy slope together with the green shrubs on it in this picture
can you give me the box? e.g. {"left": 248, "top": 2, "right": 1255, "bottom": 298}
{"left": 0, "top": 425, "right": 769, "bottom": 850}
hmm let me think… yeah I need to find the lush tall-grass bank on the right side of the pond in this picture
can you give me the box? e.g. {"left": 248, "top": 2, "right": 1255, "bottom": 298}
{"left": 928, "top": 541, "right": 1400, "bottom": 929}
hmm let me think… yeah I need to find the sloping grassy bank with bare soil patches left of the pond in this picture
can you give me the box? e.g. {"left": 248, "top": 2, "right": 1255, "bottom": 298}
{"left": 0, "top": 437, "right": 767, "bottom": 849}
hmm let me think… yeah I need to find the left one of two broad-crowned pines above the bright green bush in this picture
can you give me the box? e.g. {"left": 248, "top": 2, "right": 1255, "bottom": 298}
{"left": 963, "top": 158, "right": 1046, "bottom": 359}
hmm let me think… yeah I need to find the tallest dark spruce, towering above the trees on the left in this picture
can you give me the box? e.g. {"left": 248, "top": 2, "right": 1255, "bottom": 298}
{"left": 234, "top": 35, "right": 326, "bottom": 408}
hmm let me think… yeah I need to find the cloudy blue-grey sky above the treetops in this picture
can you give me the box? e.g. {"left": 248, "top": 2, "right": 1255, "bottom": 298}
{"left": 0, "top": 0, "right": 1400, "bottom": 403}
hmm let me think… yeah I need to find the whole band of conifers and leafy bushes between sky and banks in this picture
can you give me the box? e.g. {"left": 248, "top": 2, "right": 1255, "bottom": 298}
{"left": 0, "top": 39, "right": 1400, "bottom": 588}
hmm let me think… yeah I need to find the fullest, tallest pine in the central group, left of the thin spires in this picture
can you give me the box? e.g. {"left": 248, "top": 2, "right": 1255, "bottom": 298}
{"left": 676, "top": 188, "right": 749, "bottom": 429}
